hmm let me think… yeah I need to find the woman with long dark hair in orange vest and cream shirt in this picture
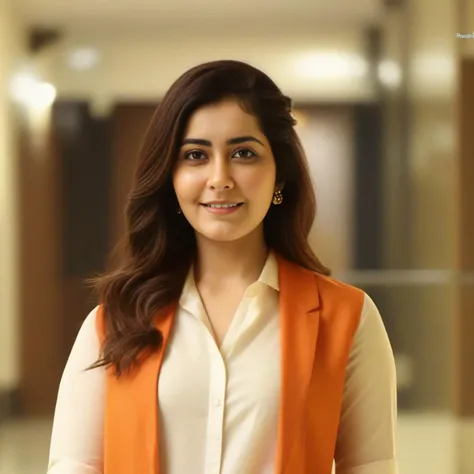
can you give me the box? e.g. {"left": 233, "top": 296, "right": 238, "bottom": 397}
{"left": 48, "top": 61, "right": 397, "bottom": 474}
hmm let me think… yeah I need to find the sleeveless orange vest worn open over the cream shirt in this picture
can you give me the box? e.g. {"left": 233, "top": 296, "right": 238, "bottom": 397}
{"left": 97, "top": 256, "right": 364, "bottom": 474}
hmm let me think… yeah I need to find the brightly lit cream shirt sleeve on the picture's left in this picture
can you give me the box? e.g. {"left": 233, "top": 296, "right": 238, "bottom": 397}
{"left": 47, "top": 308, "right": 105, "bottom": 474}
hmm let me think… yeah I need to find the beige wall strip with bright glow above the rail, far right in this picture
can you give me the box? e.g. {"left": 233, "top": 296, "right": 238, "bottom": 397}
{"left": 408, "top": 0, "right": 459, "bottom": 268}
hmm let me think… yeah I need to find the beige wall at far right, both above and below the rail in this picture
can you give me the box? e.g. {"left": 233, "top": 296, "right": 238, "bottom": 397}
{"left": 384, "top": 0, "right": 460, "bottom": 411}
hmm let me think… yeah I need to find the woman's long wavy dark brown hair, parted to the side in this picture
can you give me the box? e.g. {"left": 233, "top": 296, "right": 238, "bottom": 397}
{"left": 91, "top": 60, "right": 329, "bottom": 376}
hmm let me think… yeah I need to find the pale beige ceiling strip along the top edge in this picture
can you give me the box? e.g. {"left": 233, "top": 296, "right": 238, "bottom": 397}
{"left": 12, "top": 0, "right": 383, "bottom": 35}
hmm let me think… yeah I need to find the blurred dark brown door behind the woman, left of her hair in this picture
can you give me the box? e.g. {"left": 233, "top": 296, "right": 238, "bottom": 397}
{"left": 56, "top": 104, "right": 155, "bottom": 374}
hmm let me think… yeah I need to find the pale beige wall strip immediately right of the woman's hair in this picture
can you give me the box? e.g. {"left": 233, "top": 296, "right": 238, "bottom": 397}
{"left": 296, "top": 108, "right": 355, "bottom": 272}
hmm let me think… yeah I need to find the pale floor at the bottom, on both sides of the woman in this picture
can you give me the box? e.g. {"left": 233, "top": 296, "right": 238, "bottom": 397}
{"left": 0, "top": 415, "right": 458, "bottom": 474}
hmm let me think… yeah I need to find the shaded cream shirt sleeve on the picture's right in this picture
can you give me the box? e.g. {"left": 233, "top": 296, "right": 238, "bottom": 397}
{"left": 335, "top": 295, "right": 398, "bottom": 474}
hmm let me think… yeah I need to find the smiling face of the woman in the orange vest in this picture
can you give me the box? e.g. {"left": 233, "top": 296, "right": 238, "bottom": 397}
{"left": 173, "top": 99, "right": 276, "bottom": 242}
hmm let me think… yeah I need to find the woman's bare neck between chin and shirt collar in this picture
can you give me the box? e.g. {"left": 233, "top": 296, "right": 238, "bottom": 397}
{"left": 194, "top": 227, "right": 268, "bottom": 289}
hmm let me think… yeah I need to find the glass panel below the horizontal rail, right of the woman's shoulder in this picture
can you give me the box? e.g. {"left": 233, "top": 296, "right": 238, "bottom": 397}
{"left": 334, "top": 272, "right": 456, "bottom": 413}
